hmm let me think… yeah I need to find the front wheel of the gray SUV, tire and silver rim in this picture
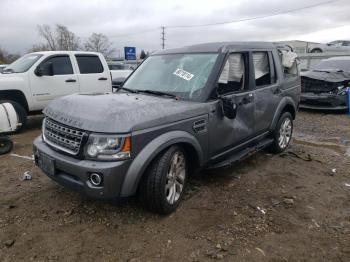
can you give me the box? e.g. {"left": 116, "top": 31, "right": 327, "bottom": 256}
{"left": 139, "top": 146, "right": 188, "bottom": 215}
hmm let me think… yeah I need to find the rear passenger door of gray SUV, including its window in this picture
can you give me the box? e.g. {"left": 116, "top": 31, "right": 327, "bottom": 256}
{"left": 252, "top": 51, "right": 282, "bottom": 135}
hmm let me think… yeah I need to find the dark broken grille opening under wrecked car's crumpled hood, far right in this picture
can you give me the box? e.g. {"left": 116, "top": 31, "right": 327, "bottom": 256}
{"left": 301, "top": 77, "right": 341, "bottom": 94}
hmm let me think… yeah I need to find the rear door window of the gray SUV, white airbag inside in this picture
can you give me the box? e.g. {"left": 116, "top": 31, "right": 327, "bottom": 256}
{"left": 253, "top": 52, "right": 273, "bottom": 88}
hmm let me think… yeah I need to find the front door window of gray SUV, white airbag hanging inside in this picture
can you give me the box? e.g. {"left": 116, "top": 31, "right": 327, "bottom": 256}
{"left": 218, "top": 53, "right": 248, "bottom": 95}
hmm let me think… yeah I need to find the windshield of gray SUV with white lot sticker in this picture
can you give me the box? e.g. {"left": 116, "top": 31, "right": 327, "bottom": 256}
{"left": 123, "top": 54, "right": 218, "bottom": 100}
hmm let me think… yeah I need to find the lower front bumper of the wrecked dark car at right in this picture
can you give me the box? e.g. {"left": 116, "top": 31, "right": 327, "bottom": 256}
{"left": 299, "top": 93, "right": 348, "bottom": 110}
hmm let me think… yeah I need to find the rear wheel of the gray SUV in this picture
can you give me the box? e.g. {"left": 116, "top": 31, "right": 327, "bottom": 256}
{"left": 269, "top": 112, "right": 293, "bottom": 154}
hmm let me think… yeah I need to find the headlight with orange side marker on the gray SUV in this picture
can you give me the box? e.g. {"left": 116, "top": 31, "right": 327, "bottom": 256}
{"left": 85, "top": 134, "right": 131, "bottom": 161}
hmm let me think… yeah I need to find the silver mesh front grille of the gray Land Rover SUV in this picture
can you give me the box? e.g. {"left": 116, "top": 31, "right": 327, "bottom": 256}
{"left": 43, "top": 118, "right": 86, "bottom": 155}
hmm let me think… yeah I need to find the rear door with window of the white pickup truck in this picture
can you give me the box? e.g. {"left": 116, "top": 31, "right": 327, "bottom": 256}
{"left": 75, "top": 54, "right": 112, "bottom": 93}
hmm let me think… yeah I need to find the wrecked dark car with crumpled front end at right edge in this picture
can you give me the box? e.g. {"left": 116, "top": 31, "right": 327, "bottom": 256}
{"left": 300, "top": 56, "right": 350, "bottom": 110}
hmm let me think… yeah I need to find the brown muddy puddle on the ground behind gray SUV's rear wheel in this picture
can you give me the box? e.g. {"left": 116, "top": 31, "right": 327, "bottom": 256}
{"left": 293, "top": 132, "right": 350, "bottom": 156}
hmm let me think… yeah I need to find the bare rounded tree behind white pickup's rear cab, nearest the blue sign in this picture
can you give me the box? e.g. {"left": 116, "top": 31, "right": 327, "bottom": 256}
{"left": 84, "top": 33, "right": 114, "bottom": 58}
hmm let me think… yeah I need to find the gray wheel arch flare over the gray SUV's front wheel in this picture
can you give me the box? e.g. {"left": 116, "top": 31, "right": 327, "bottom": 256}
{"left": 120, "top": 131, "right": 203, "bottom": 197}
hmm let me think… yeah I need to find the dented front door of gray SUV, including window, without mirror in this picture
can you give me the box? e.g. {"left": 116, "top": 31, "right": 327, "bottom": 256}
{"left": 209, "top": 52, "right": 255, "bottom": 160}
